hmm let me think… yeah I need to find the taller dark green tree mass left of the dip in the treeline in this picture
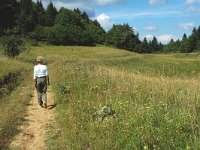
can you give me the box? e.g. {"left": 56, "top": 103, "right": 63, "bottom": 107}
{"left": 0, "top": 0, "right": 105, "bottom": 45}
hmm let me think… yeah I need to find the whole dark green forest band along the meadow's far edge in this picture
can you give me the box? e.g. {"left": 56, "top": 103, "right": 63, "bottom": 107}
{"left": 0, "top": 0, "right": 200, "bottom": 55}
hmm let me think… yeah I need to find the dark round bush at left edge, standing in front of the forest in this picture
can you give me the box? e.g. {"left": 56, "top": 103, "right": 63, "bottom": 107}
{"left": 2, "top": 35, "right": 25, "bottom": 57}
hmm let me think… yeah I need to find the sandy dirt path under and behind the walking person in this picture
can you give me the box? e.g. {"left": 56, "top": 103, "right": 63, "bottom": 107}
{"left": 10, "top": 89, "right": 56, "bottom": 150}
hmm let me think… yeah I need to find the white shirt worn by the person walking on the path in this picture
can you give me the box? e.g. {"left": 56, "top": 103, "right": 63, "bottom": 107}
{"left": 33, "top": 64, "right": 48, "bottom": 79}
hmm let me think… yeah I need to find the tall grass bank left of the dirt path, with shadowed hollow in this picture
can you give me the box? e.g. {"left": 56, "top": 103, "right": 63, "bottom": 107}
{"left": 0, "top": 56, "right": 32, "bottom": 149}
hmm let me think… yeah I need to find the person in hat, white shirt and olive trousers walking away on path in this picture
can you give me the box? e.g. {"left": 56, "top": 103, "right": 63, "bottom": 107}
{"left": 33, "top": 56, "right": 50, "bottom": 108}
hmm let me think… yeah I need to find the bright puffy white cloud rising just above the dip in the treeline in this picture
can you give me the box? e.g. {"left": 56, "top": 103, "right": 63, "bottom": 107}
{"left": 96, "top": 14, "right": 112, "bottom": 31}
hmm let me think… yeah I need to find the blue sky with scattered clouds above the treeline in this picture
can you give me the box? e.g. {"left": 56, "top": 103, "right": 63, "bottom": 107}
{"left": 34, "top": 0, "right": 200, "bottom": 44}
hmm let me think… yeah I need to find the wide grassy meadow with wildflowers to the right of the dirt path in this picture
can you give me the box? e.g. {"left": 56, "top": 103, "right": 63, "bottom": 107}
{"left": 0, "top": 46, "right": 200, "bottom": 150}
